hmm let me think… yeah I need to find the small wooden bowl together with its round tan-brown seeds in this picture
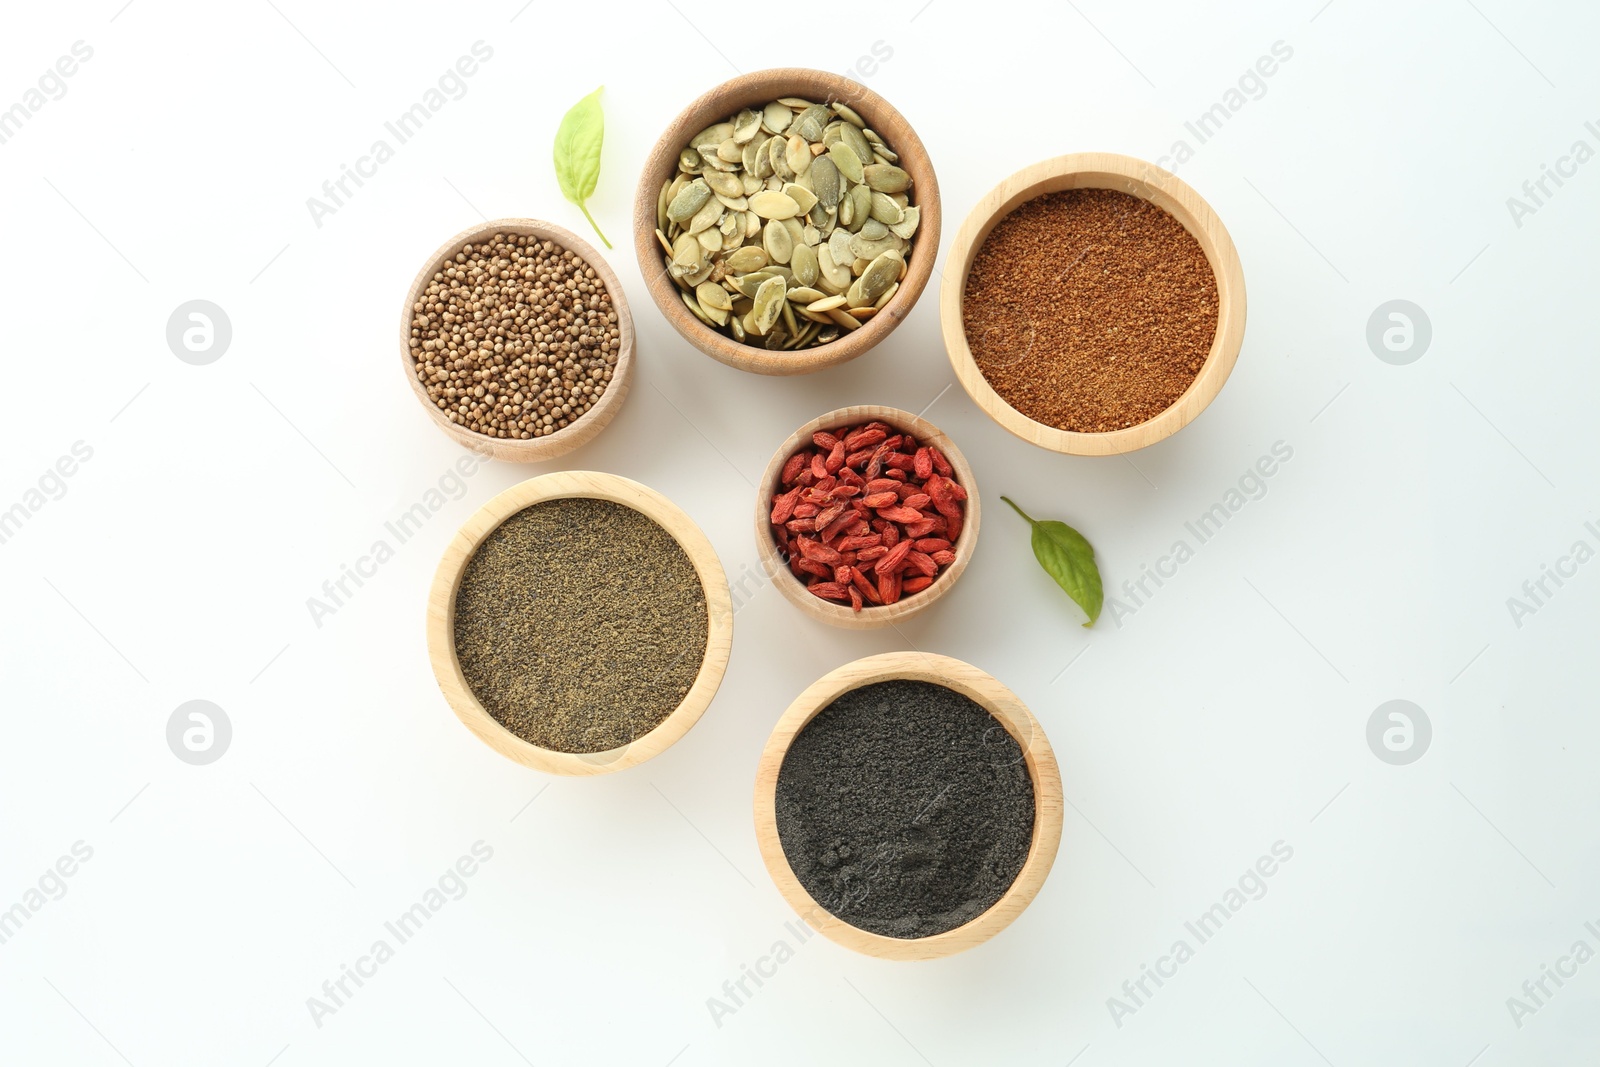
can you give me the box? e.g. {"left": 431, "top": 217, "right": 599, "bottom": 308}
{"left": 400, "top": 219, "right": 634, "bottom": 462}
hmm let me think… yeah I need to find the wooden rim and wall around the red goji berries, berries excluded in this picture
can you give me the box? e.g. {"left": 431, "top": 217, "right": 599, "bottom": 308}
{"left": 755, "top": 405, "right": 981, "bottom": 630}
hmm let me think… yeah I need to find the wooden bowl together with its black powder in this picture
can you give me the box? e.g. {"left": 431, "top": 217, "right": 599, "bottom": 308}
{"left": 755, "top": 651, "right": 1062, "bottom": 960}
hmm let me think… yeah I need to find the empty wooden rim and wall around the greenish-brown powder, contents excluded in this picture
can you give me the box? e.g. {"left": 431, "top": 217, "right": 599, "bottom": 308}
{"left": 427, "top": 470, "right": 733, "bottom": 774}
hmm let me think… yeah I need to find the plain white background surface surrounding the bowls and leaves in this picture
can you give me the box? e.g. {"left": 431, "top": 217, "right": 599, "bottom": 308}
{"left": 0, "top": 0, "right": 1600, "bottom": 1067}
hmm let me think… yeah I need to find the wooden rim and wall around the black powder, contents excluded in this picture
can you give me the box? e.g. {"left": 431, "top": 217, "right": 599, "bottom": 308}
{"left": 755, "top": 653, "right": 1062, "bottom": 960}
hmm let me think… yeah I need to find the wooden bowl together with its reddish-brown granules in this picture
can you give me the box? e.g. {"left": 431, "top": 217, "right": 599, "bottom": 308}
{"left": 939, "top": 152, "right": 1245, "bottom": 456}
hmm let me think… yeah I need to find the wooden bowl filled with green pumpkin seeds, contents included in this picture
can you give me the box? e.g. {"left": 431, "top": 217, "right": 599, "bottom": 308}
{"left": 634, "top": 67, "right": 939, "bottom": 374}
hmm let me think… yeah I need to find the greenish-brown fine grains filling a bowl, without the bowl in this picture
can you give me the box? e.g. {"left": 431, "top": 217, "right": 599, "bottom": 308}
{"left": 456, "top": 498, "right": 710, "bottom": 752}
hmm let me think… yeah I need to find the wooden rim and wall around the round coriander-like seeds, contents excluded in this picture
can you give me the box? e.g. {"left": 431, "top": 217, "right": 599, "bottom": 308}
{"left": 400, "top": 219, "right": 634, "bottom": 462}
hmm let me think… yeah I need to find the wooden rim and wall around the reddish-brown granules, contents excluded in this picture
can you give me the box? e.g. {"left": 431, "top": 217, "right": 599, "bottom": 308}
{"left": 939, "top": 152, "right": 1245, "bottom": 456}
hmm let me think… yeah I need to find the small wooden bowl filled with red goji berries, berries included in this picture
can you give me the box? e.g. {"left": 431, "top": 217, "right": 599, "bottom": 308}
{"left": 755, "top": 405, "right": 979, "bottom": 629}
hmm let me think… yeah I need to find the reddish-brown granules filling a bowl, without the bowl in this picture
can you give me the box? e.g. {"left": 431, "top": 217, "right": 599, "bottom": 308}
{"left": 962, "top": 189, "right": 1218, "bottom": 434}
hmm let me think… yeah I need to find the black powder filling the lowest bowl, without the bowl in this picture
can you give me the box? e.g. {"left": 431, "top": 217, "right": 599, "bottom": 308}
{"left": 776, "top": 681, "right": 1034, "bottom": 937}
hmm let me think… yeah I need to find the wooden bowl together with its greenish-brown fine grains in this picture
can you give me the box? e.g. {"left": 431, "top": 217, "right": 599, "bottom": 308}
{"left": 427, "top": 470, "right": 733, "bottom": 774}
